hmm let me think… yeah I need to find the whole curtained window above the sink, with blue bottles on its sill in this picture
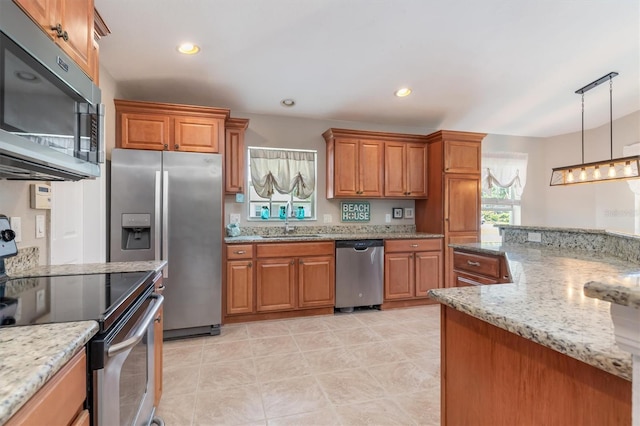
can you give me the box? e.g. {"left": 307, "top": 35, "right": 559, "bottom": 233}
{"left": 247, "top": 147, "right": 318, "bottom": 221}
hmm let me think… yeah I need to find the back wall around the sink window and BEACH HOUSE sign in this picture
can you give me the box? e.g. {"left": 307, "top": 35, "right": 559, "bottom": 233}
{"left": 224, "top": 111, "right": 434, "bottom": 226}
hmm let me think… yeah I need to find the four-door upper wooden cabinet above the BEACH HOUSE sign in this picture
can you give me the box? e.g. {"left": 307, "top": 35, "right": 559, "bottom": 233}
{"left": 322, "top": 129, "right": 427, "bottom": 198}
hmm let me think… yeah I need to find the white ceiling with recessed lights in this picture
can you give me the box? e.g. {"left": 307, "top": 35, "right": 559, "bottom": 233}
{"left": 95, "top": 0, "right": 640, "bottom": 136}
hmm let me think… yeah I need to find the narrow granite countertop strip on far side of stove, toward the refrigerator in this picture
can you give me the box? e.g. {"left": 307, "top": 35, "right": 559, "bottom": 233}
{"left": 9, "top": 260, "right": 167, "bottom": 278}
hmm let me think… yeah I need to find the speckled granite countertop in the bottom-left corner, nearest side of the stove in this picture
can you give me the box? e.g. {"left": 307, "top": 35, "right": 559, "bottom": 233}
{"left": 0, "top": 321, "right": 98, "bottom": 425}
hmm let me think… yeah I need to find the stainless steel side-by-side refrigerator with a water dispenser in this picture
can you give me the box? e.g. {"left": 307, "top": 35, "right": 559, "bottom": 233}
{"left": 109, "top": 149, "right": 223, "bottom": 338}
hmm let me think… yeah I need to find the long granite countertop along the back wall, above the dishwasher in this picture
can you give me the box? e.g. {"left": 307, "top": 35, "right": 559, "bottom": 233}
{"left": 224, "top": 232, "right": 444, "bottom": 244}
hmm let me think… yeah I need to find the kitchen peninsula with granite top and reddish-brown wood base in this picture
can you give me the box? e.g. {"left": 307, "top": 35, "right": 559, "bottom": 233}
{"left": 430, "top": 238, "right": 640, "bottom": 425}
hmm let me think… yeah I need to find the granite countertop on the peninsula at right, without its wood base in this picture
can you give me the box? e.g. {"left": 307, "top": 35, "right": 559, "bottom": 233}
{"left": 429, "top": 243, "right": 640, "bottom": 380}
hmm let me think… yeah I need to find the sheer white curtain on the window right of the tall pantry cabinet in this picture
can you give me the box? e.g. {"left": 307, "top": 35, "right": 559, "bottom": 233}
{"left": 482, "top": 152, "right": 529, "bottom": 198}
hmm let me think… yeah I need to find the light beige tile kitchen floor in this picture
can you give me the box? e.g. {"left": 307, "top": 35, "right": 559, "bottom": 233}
{"left": 158, "top": 305, "right": 440, "bottom": 426}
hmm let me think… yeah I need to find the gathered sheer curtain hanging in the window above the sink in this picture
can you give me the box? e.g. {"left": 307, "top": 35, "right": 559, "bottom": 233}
{"left": 249, "top": 148, "right": 316, "bottom": 199}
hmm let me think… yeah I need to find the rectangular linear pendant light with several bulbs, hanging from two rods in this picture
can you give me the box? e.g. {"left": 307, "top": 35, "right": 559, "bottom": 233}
{"left": 549, "top": 72, "right": 640, "bottom": 186}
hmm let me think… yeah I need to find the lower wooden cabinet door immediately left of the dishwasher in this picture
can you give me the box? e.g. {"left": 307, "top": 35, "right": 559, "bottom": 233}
{"left": 298, "top": 256, "right": 335, "bottom": 308}
